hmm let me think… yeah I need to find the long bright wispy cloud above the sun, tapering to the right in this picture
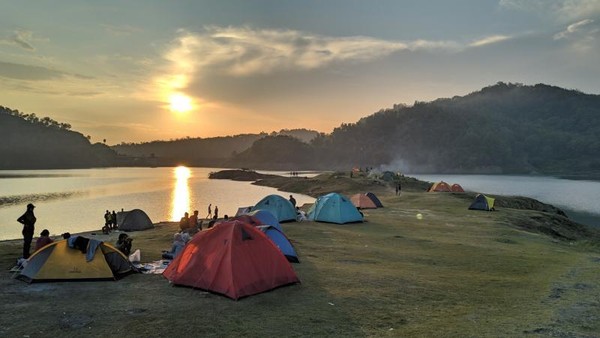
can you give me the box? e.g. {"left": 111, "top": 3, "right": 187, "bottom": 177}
{"left": 156, "top": 26, "right": 482, "bottom": 101}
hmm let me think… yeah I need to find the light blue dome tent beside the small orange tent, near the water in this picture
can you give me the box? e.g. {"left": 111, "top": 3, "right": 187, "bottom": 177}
{"left": 308, "top": 192, "right": 363, "bottom": 224}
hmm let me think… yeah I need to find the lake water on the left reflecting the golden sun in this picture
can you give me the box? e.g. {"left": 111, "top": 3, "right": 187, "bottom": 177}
{"left": 0, "top": 167, "right": 314, "bottom": 240}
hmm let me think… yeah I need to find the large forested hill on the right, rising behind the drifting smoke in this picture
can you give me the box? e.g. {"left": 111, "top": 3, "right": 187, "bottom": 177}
{"left": 231, "top": 82, "right": 600, "bottom": 177}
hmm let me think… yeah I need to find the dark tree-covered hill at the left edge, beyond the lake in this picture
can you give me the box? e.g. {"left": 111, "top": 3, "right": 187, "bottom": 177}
{"left": 0, "top": 106, "right": 116, "bottom": 169}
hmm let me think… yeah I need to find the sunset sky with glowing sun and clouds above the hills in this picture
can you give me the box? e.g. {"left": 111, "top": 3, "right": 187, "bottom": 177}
{"left": 0, "top": 0, "right": 600, "bottom": 145}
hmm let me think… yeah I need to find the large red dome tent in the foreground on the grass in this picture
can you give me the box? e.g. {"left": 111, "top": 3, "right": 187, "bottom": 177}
{"left": 163, "top": 220, "right": 300, "bottom": 299}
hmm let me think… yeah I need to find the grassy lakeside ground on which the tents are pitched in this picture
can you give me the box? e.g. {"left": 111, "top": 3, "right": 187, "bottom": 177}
{"left": 0, "top": 174, "right": 600, "bottom": 337}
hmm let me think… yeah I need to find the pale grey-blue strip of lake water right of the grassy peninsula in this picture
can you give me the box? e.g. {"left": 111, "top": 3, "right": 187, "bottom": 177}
{"left": 409, "top": 175, "right": 600, "bottom": 227}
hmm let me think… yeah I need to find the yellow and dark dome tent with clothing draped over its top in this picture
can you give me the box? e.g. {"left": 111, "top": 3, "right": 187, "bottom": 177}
{"left": 17, "top": 240, "right": 133, "bottom": 283}
